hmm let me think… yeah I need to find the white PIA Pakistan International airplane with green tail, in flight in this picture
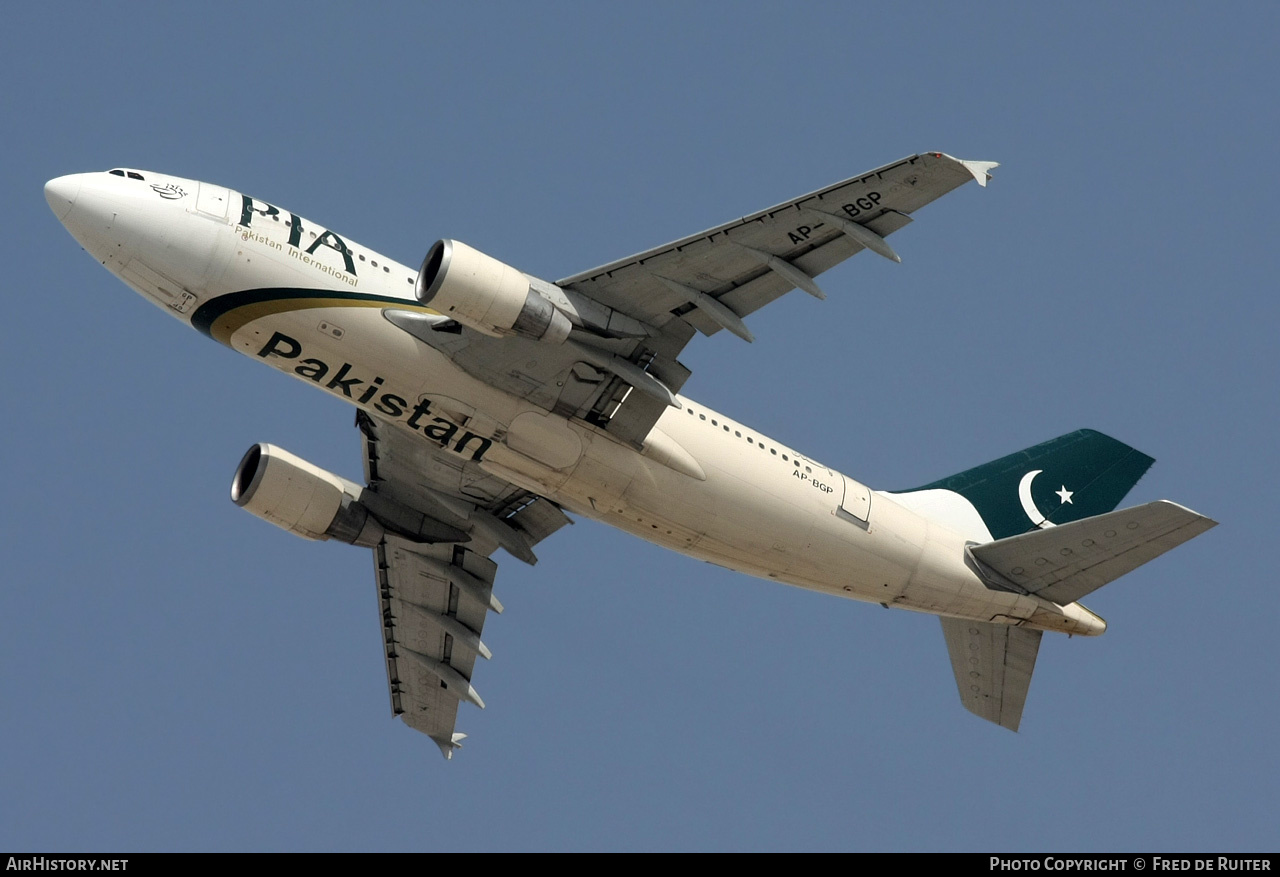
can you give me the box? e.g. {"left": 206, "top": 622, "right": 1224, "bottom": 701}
{"left": 45, "top": 152, "right": 1216, "bottom": 758}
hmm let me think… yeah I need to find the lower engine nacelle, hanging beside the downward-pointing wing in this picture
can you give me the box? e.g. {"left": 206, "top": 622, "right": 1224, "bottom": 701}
{"left": 232, "top": 444, "right": 385, "bottom": 547}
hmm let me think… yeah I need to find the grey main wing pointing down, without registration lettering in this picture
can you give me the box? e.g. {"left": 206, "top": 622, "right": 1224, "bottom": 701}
{"left": 356, "top": 412, "right": 571, "bottom": 758}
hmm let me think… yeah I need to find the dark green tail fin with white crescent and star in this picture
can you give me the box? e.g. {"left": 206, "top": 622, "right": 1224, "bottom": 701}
{"left": 904, "top": 429, "right": 1156, "bottom": 539}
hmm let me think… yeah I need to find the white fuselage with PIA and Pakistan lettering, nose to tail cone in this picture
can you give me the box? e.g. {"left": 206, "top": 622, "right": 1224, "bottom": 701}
{"left": 46, "top": 172, "right": 1105, "bottom": 634}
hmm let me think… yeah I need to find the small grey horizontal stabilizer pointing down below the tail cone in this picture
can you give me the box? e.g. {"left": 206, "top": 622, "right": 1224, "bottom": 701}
{"left": 940, "top": 618, "right": 1041, "bottom": 731}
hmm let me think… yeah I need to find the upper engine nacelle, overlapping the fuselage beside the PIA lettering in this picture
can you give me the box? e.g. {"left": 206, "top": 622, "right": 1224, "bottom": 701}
{"left": 415, "top": 239, "right": 572, "bottom": 344}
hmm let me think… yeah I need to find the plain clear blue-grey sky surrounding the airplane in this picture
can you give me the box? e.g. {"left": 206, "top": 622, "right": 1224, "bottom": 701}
{"left": 0, "top": 3, "right": 1280, "bottom": 851}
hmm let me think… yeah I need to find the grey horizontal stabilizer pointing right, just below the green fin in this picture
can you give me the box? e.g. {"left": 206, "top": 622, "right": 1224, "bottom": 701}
{"left": 969, "top": 499, "right": 1217, "bottom": 606}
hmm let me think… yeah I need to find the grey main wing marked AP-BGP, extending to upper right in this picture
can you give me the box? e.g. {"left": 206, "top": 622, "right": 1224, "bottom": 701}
{"left": 388, "top": 152, "right": 996, "bottom": 447}
